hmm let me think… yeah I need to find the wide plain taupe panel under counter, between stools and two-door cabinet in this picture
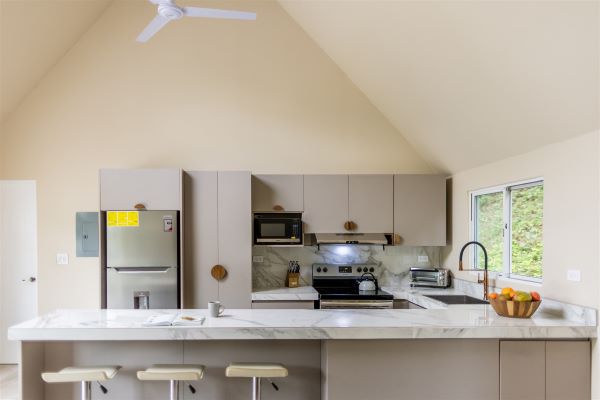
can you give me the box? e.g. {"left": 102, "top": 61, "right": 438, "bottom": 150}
{"left": 322, "top": 339, "right": 499, "bottom": 400}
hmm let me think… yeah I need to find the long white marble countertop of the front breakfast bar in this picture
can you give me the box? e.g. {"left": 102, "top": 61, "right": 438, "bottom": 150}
{"left": 8, "top": 305, "right": 597, "bottom": 341}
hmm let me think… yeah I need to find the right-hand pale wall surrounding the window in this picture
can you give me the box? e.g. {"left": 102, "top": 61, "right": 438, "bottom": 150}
{"left": 444, "top": 132, "right": 600, "bottom": 307}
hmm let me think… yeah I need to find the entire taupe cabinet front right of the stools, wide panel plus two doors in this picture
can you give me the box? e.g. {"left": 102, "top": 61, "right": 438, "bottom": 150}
{"left": 321, "top": 339, "right": 591, "bottom": 400}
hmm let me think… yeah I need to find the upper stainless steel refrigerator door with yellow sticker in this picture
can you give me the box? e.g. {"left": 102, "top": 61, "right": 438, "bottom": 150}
{"left": 106, "top": 211, "right": 179, "bottom": 267}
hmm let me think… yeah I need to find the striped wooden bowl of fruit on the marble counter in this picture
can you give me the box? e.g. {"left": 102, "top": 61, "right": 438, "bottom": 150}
{"left": 488, "top": 288, "right": 542, "bottom": 318}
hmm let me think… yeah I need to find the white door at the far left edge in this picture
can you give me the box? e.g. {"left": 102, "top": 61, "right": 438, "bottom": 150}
{"left": 0, "top": 181, "right": 37, "bottom": 364}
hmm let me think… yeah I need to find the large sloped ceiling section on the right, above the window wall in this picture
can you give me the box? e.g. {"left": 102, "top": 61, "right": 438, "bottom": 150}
{"left": 280, "top": 0, "right": 600, "bottom": 172}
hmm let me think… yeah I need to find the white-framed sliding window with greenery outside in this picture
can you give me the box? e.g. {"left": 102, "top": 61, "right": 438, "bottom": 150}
{"left": 471, "top": 180, "right": 544, "bottom": 282}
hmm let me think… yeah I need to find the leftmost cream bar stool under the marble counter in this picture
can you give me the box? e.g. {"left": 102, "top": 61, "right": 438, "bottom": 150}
{"left": 42, "top": 365, "right": 121, "bottom": 400}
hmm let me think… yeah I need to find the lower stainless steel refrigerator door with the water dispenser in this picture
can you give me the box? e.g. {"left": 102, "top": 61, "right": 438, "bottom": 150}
{"left": 106, "top": 267, "right": 179, "bottom": 309}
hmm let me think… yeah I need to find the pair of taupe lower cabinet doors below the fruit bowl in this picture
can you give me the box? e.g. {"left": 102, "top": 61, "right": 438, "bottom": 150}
{"left": 500, "top": 340, "right": 591, "bottom": 400}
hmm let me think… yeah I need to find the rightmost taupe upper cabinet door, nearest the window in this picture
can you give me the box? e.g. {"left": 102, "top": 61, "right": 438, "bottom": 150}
{"left": 394, "top": 175, "right": 446, "bottom": 246}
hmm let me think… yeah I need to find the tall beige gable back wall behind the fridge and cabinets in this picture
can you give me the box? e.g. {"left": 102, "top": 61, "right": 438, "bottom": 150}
{"left": 0, "top": 1, "right": 431, "bottom": 312}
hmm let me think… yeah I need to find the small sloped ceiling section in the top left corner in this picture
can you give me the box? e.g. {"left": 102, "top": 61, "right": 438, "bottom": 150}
{"left": 0, "top": 0, "right": 111, "bottom": 122}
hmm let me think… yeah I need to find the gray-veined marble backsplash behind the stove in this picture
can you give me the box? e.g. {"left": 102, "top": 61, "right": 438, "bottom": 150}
{"left": 252, "top": 245, "right": 441, "bottom": 291}
